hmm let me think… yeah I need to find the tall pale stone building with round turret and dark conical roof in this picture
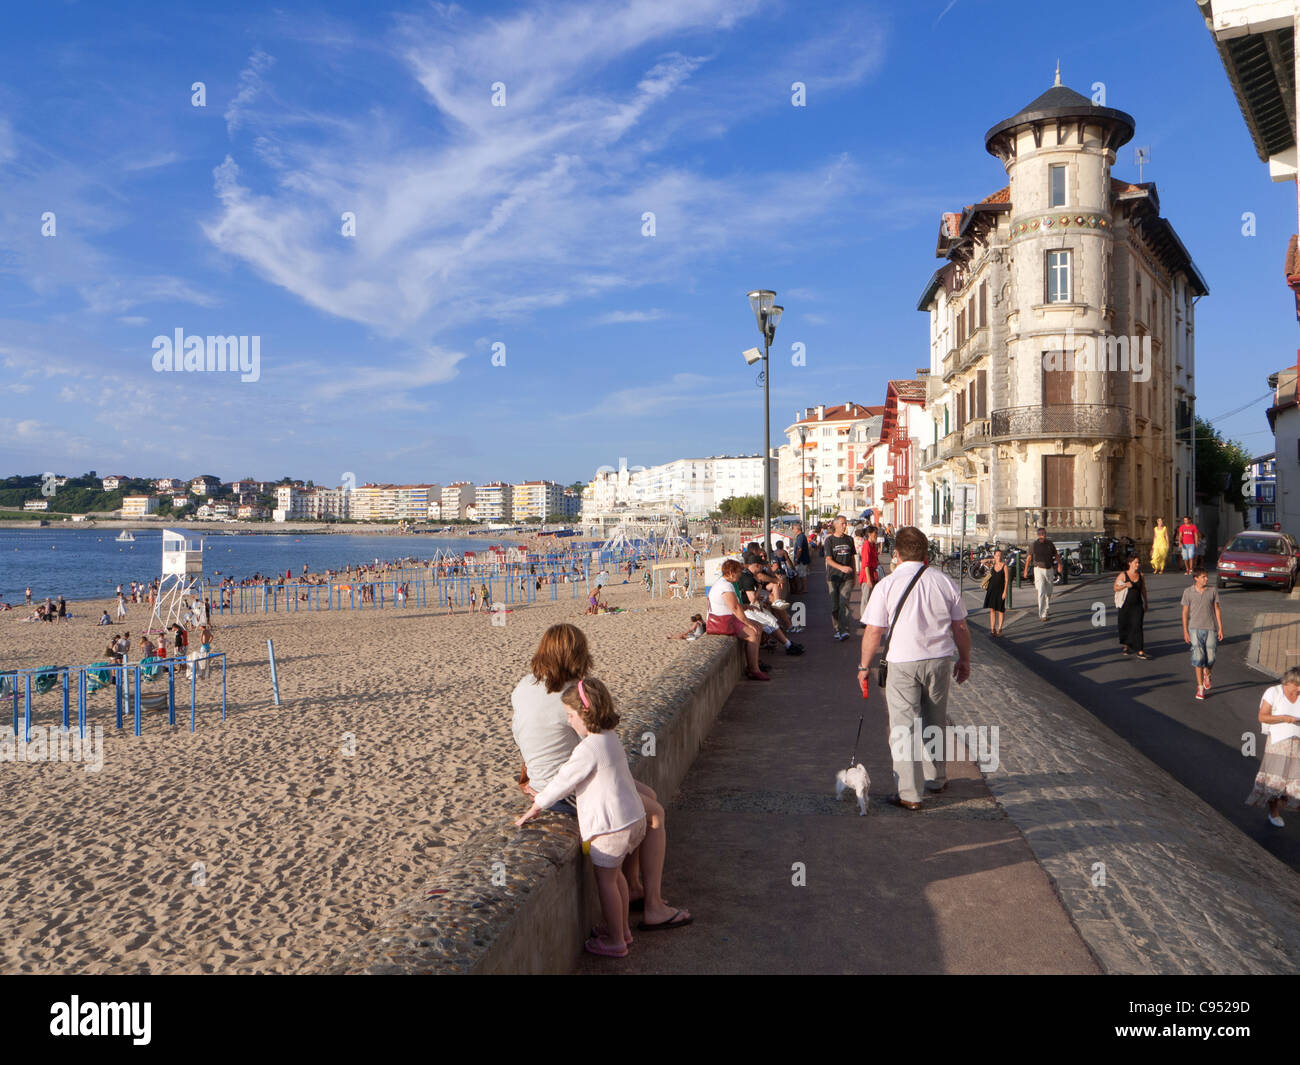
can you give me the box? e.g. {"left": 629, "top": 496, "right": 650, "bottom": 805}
{"left": 917, "top": 73, "right": 1206, "bottom": 542}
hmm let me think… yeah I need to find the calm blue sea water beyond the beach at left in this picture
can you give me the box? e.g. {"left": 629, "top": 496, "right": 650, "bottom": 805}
{"left": 0, "top": 529, "right": 530, "bottom": 603}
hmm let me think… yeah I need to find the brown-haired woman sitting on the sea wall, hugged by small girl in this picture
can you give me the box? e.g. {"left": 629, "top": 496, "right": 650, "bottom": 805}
{"left": 510, "top": 623, "right": 692, "bottom": 931}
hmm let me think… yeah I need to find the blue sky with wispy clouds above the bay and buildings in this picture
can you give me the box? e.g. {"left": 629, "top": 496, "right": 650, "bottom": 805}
{"left": 0, "top": 0, "right": 1296, "bottom": 484}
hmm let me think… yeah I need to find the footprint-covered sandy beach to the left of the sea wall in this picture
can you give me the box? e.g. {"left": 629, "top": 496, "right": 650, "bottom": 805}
{"left": 0, "top": 583, "right": 705, "bottom": 973}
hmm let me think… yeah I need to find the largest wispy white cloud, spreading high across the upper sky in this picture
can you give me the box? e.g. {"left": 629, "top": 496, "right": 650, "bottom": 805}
{"left": 204, "top": 0, "right": 889, "bottom": 356}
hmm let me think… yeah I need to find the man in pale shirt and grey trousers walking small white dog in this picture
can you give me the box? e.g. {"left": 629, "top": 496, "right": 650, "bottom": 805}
{"left": 858, "top": 525, "right": 971, "bottom": 810}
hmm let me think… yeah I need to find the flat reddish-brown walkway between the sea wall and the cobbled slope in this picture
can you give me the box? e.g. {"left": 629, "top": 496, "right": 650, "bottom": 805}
{"left": 580, "top": 566, "right": 1099, "bottom": 973}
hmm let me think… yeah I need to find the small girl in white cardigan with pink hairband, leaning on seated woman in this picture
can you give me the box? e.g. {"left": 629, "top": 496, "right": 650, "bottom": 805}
{"left": 515, "top": 679, "right": 646, "bottom": 958}
